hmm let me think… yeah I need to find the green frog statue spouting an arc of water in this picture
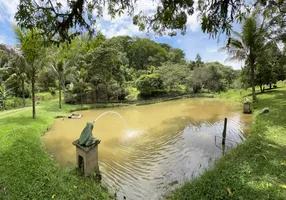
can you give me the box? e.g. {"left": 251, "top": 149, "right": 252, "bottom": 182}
{"left": 78, "top": 122, "right": 100, "bottom": 147}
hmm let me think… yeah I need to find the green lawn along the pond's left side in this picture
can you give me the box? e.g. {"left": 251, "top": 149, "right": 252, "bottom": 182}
{"left": 0, "top": 101, "right": 114, "bottom": 199}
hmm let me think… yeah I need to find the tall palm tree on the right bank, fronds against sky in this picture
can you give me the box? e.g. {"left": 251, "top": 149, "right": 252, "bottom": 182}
{"left": 221, "top": 15, "right": 268, "bottom": 101}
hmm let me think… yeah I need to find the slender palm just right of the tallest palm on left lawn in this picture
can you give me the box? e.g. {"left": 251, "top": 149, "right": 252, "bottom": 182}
{"left": 51, "top": 58, "right": 75, "bottom": 109}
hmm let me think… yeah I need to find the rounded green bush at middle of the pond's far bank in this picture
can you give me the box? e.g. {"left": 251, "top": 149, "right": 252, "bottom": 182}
{"left": 136, "top": 73, "right": 164, "bottom": 96}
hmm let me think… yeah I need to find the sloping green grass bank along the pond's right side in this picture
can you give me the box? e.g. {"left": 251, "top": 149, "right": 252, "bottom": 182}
{"left": 167, "top": 87, "right": 286, "bottom": 200}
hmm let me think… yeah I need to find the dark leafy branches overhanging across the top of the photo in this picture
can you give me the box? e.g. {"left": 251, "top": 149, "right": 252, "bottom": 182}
{"left": 15, "top": 0, "right": 280, "bottom": 43}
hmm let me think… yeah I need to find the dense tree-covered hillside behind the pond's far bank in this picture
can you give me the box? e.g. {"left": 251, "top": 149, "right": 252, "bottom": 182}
{"left": 1, "top": 31, "right": 244, "bottom": 109}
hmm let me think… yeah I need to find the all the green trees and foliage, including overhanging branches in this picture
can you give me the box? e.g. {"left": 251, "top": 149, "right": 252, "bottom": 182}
{"left": 0, "top": 0, "right": 286, "bottom": 117}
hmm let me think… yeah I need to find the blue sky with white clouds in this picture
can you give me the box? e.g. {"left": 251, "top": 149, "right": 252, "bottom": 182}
{"left": 0, "top": 0, "right": 243, "bottom": 69}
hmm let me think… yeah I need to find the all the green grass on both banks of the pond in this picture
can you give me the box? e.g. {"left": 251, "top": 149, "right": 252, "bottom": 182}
{"left": 0, "top": 87, "right": 286, "bottom": 200}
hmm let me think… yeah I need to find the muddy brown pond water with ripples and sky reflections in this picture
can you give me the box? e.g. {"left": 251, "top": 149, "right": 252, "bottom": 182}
{"left": 45, "top": 99, "right": 251, "bottom": 199}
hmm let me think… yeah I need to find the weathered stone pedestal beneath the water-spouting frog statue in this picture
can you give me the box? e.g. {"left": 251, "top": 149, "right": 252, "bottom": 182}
{"left": 72, "top": 140, "right": 100, "bottom": 176}
